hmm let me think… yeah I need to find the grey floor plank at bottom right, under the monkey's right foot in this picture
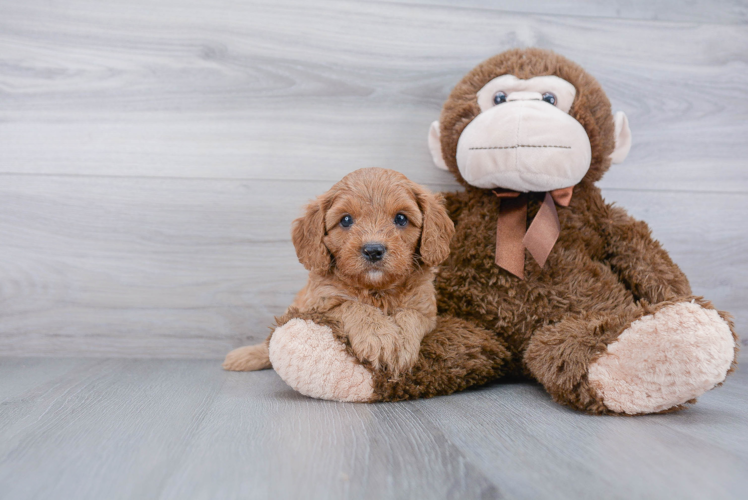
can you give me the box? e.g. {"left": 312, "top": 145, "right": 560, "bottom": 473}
{"left": 422, "top": 374, "right": 748, "bottom": 498}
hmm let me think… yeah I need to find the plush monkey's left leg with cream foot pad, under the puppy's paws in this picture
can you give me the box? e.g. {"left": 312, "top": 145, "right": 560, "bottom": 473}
{"left": 270, "top": 312, "right": 510, "bottom": 402}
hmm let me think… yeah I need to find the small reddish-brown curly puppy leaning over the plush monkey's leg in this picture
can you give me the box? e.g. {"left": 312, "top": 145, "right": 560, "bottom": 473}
{"left": 223, "top": 168, "right": 454, "bottom": 374}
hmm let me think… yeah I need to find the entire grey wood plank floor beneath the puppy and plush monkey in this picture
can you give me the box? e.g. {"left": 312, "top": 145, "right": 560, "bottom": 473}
{"left": 0, "top": 358, "right": 748, "bottom": 500}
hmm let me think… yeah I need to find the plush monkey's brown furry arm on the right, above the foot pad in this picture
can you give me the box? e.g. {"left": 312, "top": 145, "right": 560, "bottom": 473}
{"left": 602, "top": 207, "right": 691, "bottom": 304}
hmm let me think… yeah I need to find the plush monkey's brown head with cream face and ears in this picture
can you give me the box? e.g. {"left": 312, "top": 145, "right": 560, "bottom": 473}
{"left": 429, "top": 49, "right": 631, "bottom": 193}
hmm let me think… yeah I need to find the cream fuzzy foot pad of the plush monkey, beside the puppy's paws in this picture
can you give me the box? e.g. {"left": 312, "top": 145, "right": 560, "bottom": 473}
{"left": 270, "top": 318, "right": 374, "bottom": 402}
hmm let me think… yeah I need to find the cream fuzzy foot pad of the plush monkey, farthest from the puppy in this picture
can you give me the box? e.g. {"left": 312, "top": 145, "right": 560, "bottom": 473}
{"left": 589, "top": 302, "right": 735, "bottom": 415}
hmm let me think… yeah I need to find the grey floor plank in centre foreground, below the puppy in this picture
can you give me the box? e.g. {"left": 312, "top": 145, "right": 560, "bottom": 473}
{"left": 163, "top": 371, "right": 499, "bottom": 499}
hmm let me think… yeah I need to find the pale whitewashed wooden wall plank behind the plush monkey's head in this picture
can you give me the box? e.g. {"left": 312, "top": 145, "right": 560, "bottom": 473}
{"left": 0, "top": 0, "right": 748, "bottom": 189}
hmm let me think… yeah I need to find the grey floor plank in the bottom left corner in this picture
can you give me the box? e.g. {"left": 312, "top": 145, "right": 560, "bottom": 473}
{"left": 0, "top": 360, "right": 223, "bottom": 499}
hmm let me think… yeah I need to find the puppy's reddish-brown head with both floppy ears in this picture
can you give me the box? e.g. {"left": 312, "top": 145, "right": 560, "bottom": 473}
{"left": 293, "top": 168, "right": 454, "bottom": 288}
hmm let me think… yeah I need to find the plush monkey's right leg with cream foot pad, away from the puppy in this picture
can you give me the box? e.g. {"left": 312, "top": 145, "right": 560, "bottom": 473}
{"left": 524, "top": 297, "right": 736, "bottom": 415}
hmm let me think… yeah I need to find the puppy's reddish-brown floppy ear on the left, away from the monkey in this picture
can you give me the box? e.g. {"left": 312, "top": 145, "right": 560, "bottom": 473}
{"left": 291, "top": 195, "right": 331, "bottom": 271}
